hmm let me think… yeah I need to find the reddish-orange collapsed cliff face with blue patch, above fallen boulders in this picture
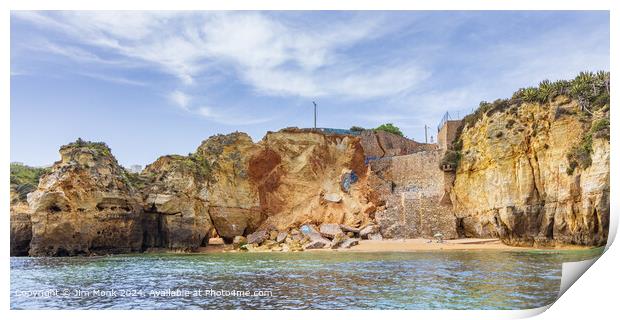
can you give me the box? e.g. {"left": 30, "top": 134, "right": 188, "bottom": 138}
{"left": 254, "top": 130, "right": 376, "bottom": 230}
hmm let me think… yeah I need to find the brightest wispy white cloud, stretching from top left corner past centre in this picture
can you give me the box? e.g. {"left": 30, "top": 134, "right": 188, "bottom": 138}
{"left": 13, "top": 11, "right": 427, "bottom": 99}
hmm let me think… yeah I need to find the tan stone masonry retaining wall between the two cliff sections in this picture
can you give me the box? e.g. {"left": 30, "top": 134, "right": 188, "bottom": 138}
{"left": 371, "top": 150, "right": 458, "bottom": 238}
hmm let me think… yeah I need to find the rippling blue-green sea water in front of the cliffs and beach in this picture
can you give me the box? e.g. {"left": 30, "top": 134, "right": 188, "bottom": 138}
{"left": 10, "top": 249, "right": 602, "bottom": 309}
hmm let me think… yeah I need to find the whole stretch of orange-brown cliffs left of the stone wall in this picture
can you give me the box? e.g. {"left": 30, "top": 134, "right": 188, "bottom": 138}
{"left": 11, "top": 129, "right": 375, "bottom": 256}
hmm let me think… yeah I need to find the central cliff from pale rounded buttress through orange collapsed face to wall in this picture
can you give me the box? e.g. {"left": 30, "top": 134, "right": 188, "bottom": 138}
{"left": 174, "top": 129, "right": 374, "bottom": 241}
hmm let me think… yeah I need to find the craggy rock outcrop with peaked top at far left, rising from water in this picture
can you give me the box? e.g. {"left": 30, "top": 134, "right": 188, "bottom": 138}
{"left": 28, "top": 140, "right": 142, "bottom": 256}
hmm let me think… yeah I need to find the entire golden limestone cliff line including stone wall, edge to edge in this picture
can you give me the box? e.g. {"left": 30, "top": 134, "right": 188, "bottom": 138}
{"left": 10, "top": 73, "right": 610, "bottom": 256}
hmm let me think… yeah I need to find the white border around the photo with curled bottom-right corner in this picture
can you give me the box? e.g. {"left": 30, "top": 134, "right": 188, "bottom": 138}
{"left": 0, "top": 0, "right": 620, "bottom": 320}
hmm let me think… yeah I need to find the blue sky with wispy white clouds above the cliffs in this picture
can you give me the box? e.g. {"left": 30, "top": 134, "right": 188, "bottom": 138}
{"left": 10, "top": 11, "right": 610, "bottom": 166}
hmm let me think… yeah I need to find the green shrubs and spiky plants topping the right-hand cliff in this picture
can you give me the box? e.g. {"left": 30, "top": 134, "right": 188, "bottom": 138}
{"left": 442, "top": 71, "right": 610, "bottom": 174}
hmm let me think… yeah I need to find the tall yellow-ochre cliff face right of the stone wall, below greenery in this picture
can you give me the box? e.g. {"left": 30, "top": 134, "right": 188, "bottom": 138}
{"left": 451, "top": 96, "right": 609, "bottom": 245}
